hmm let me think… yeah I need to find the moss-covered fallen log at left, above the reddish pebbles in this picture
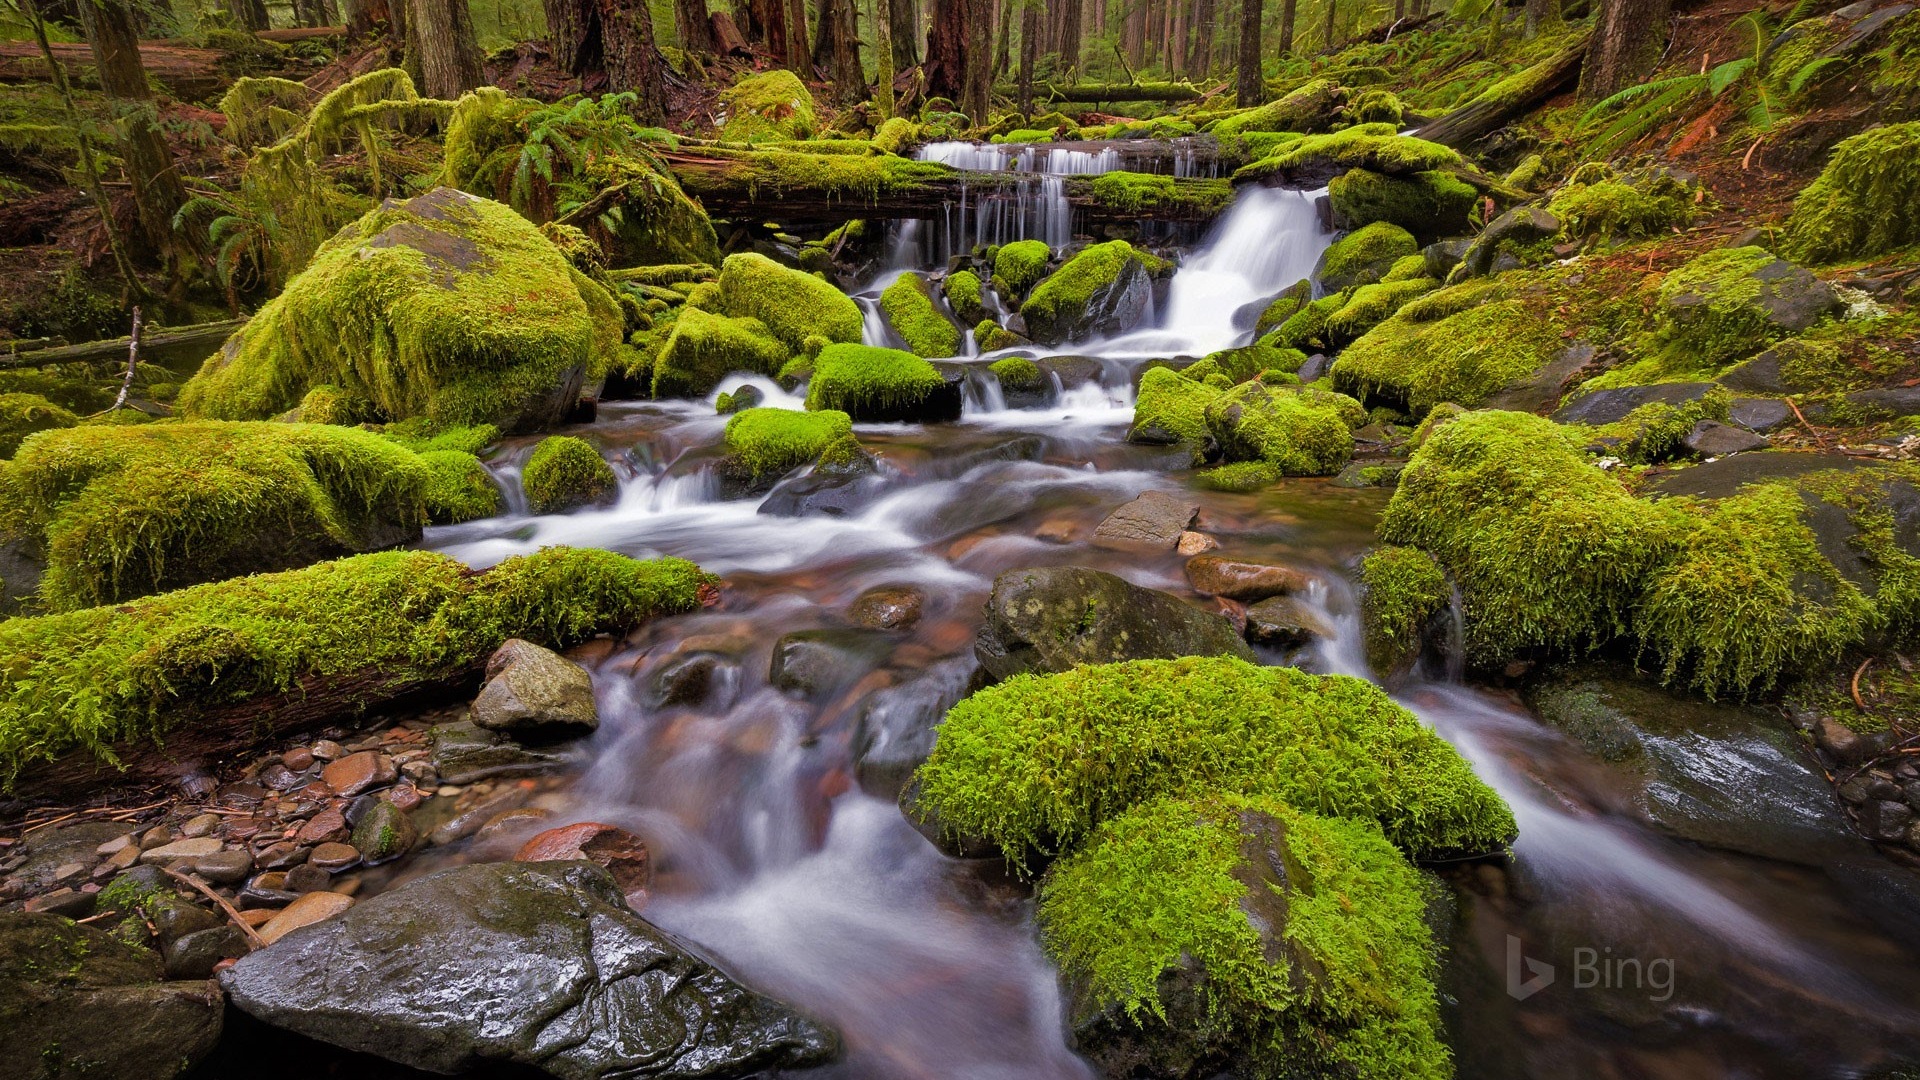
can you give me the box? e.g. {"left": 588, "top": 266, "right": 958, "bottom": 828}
{"left": 0, "top": 548, "right": 712, "bottom": 794}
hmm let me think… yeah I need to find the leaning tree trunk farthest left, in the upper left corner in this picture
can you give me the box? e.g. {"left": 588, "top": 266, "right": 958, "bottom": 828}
{"left": 81, "top": 0, "right": 186, "bottom": 269}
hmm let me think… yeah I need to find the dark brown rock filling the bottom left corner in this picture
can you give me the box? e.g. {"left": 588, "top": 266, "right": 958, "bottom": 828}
{"left": 0, "top": 915, "right": 223, "bottom": 1080}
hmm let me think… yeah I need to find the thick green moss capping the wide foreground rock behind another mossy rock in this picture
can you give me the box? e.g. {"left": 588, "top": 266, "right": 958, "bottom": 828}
{"left": 916, "top": 645, "right": 1515, "bottom": 861}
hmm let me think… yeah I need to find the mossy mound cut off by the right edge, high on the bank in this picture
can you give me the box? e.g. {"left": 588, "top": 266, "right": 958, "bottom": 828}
{"left": 1786, "top": 121, "right": 1920, "bottom": 261}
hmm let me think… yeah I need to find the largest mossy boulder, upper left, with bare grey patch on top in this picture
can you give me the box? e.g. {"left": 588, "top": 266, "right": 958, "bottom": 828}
{"left": 179, "top": 188, "right": 622, "bottom": 430}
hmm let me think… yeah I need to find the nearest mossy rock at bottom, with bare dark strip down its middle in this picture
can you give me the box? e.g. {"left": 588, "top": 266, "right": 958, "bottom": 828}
{"left": 1037, "top": 796, "right": 1453, "bottom": 1080}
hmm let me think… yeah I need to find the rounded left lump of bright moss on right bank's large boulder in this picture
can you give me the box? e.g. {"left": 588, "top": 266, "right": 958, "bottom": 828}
{"left": 1379, "top": 411, "right": 1678, "bottom": 667}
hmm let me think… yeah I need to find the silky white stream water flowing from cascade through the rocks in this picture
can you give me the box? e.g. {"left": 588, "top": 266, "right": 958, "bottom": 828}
{"left": 416, "top": 146, "right": 1920, "bottom": 1080}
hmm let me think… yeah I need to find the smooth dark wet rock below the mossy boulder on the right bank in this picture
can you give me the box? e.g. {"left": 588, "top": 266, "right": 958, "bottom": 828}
{"left": 1528, "top": 667, "right": 1859, "bottom": 865}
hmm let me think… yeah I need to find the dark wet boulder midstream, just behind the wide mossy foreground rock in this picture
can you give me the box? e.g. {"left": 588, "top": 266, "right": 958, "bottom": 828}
{"left": 973, "top": 568, "right": 1252, "bottom": 678}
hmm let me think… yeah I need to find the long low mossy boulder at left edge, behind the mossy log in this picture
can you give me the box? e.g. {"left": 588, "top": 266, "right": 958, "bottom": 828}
{"left": 8, "top": 421, "right": 432, "bottom": 611}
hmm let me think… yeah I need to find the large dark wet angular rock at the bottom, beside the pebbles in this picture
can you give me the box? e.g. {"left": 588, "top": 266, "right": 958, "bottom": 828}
{"left": 221, "top": 863, "right": 837, "bottom": 1080}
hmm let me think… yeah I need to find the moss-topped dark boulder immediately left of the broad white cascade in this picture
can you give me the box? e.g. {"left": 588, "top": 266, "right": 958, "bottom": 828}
{"left": 1020, "top": 240, "right": 1173, "bottom": 344}
